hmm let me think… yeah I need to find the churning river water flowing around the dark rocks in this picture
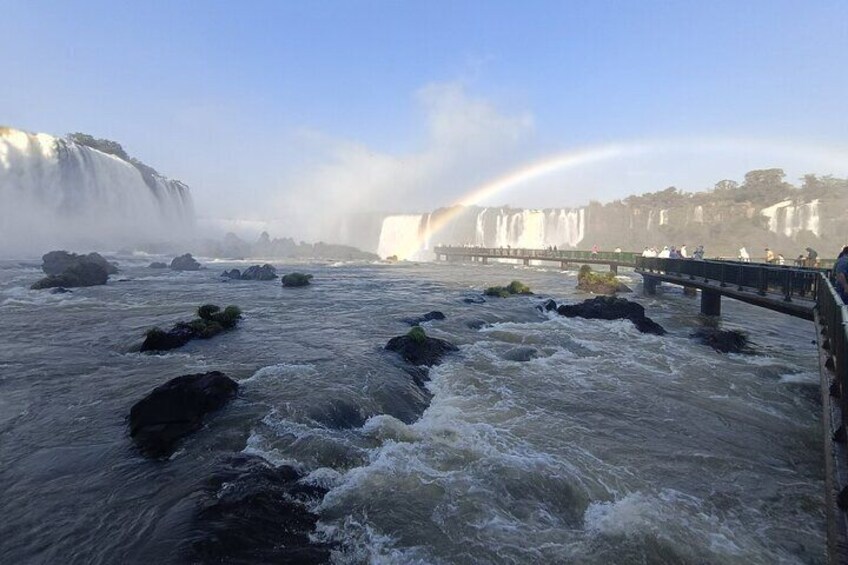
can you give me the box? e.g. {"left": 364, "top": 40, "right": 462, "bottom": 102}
{"left": 0, "top": 257, "right": 825, "bottom": 564}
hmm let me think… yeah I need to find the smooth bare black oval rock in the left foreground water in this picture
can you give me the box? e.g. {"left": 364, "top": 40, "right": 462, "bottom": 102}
{"left": 129, "top": 371, "right": 238, "bottom": 457}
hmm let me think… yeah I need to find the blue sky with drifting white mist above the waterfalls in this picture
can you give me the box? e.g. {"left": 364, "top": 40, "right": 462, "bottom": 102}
{"left": 0, "top": 0, "right": 848, "bottom": 236}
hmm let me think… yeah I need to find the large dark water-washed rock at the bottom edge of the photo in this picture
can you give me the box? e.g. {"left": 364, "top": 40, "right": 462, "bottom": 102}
{"left": 186, "top": 455, "right": 333, "bottom": 564}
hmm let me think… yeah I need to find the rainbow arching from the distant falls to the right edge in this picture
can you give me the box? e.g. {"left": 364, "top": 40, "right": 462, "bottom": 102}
{"left": 398, "top": 138, "right": 848, "bottom": 259}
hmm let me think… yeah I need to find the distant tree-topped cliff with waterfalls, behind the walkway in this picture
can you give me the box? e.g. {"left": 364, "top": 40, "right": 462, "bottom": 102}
{"left": 366, "top": 169, "right": 848, "bottom": 259}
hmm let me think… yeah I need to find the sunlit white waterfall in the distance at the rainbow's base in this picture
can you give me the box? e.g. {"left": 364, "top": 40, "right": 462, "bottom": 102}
{"left": 377, "top": 208, "right": 586, "bottom": 259}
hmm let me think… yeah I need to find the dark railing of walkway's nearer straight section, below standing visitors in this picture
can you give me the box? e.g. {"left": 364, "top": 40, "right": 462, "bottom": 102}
{"left": 636, "top": 257, "right": 828, "bottom": 302}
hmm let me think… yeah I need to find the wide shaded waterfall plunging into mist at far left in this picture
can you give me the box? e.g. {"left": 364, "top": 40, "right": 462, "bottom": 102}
{"left": 0, "top": 128, "right": 194, "bottom": 254}
